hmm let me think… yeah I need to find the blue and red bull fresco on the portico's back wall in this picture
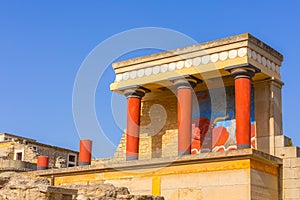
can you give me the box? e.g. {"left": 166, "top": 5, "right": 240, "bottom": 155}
{"left": 192, "top": 86, "right": 256, "bottom": 154}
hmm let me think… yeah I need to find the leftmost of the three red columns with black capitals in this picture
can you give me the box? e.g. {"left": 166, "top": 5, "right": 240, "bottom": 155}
{"left": 124, "top": 87, "right": 150, "bottom": 160}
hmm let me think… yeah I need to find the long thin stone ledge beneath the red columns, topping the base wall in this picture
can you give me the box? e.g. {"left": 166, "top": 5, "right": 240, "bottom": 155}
{"left": 31, "top": 149, "right": 282, "bottom": 177}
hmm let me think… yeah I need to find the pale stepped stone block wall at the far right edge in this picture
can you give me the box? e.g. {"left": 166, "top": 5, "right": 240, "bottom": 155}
{"left": 275, "top": 135, "right": 300, "bottom": 200}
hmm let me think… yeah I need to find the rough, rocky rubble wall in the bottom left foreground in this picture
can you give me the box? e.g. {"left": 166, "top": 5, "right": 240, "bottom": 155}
{"left": 0, "top": 172, "right": 164, "bottom": 200}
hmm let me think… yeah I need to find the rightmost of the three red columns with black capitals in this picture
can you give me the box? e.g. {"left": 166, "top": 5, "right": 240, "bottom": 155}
{"left": 225, "top": 65, "right": 260, "bottom": 149}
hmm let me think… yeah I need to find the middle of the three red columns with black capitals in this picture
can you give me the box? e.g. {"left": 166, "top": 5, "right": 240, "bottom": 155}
{"left": 173, "top": 76, "right": 200, "bottom": 156}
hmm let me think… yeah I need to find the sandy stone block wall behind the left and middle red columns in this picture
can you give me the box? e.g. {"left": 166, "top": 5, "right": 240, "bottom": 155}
{"left": 114, "top": 90, "right": 178, "bottom": 160}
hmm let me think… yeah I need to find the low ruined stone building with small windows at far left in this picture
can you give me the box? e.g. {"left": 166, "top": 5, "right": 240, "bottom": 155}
{"left": 0, "top": 133, "right": 78, "bottom": 171}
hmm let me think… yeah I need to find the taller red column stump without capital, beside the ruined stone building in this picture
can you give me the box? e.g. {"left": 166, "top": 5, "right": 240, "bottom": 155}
{"left": 78, "top": 140, "right": 92, "bottom": 166}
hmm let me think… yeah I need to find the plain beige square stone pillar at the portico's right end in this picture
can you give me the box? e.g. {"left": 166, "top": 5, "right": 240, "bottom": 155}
{"left": 253, "top": 77, "right": 284, "bottom": 155}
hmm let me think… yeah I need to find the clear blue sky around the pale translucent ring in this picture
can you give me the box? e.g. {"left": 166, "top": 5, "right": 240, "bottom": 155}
{"left": 0, "top": 0, "right": 300, "bottom": 158}
